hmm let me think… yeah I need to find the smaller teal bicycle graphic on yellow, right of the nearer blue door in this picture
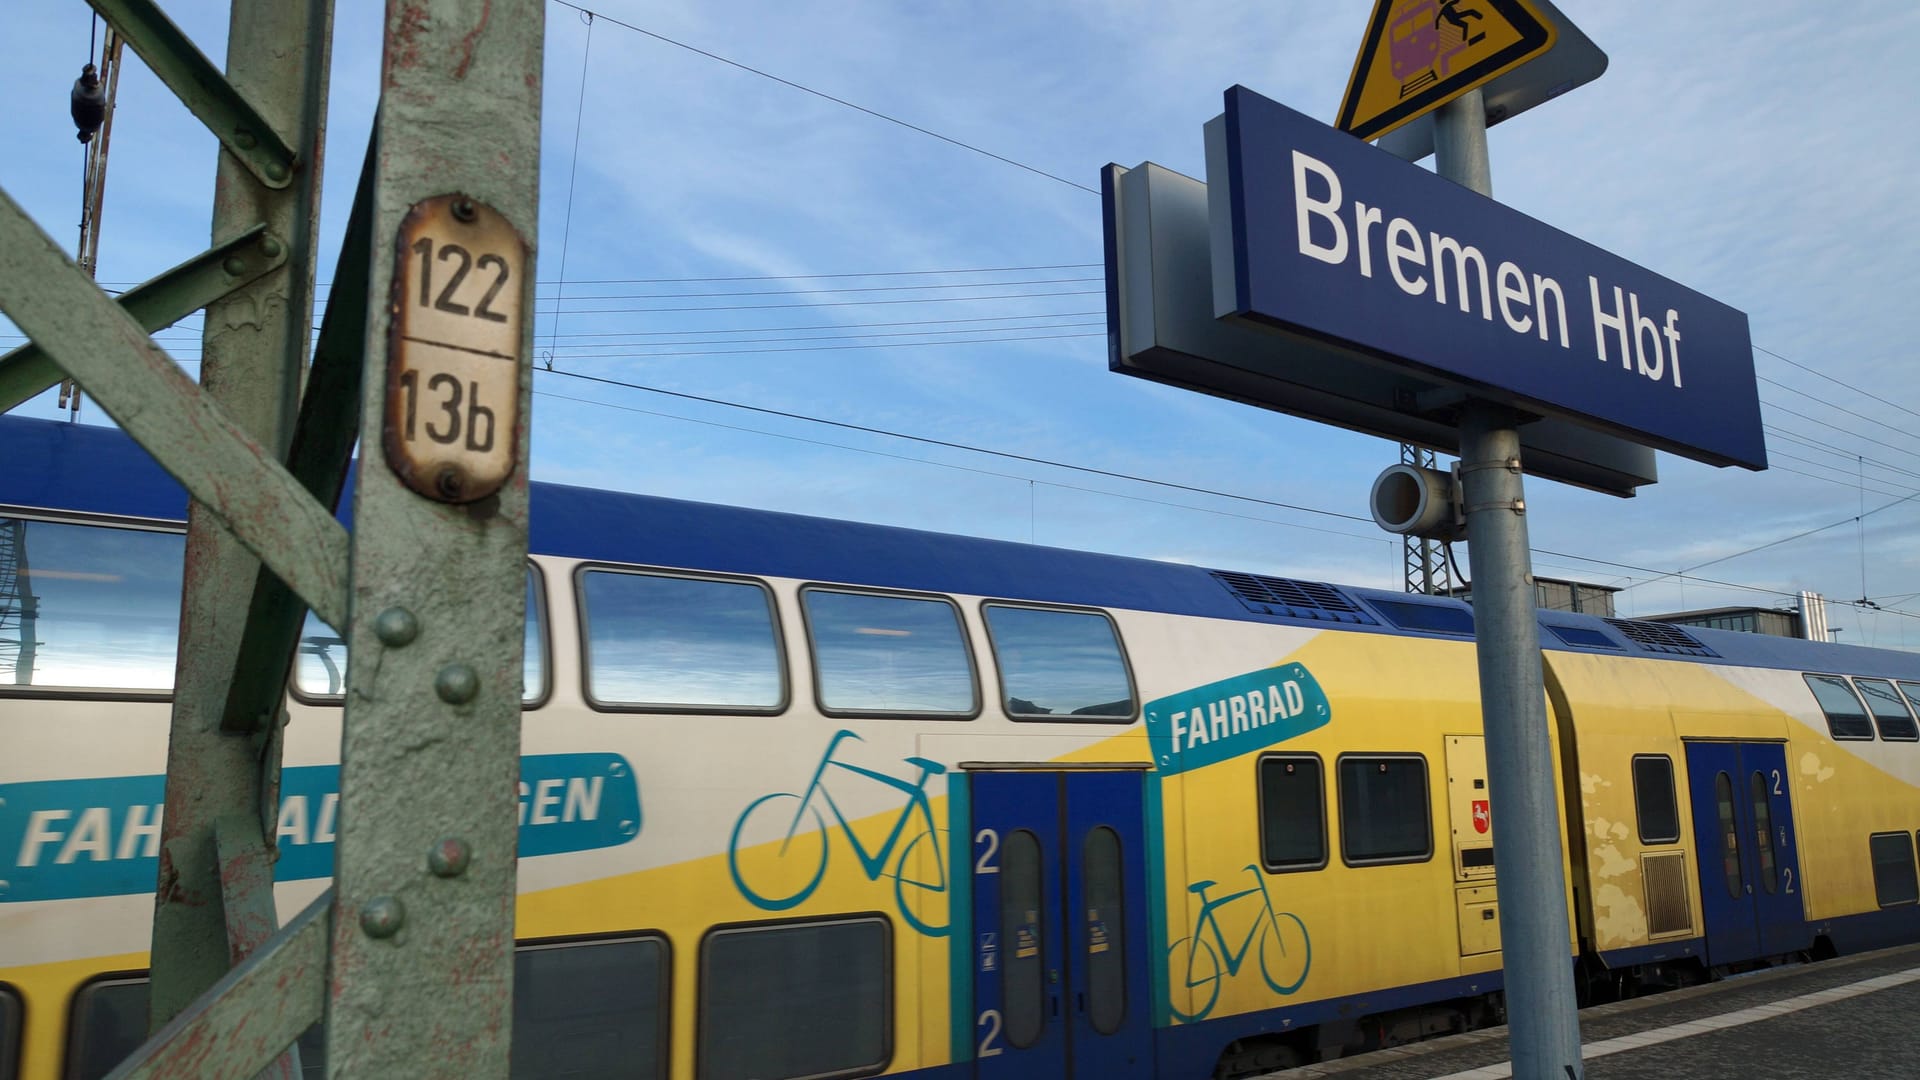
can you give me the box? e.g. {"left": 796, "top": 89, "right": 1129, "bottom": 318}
{"left": 1167, "top": 865, "right": 1313, "bottom": 1024}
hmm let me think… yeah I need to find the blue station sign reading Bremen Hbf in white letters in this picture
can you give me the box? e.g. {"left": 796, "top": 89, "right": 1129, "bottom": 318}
{"left": 1208, "top": 86, "right": 1766, "bottom": 469}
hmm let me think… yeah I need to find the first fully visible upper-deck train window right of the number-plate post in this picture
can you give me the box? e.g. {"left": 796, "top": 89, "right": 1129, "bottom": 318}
{"left": 580, "top": 569, "right": 787, "bottom": 713}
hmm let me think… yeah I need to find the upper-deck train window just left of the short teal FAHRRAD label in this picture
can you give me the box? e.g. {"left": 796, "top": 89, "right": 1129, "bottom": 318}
{"left": 983, "top": 603, "right": 1133, "bottom": 721}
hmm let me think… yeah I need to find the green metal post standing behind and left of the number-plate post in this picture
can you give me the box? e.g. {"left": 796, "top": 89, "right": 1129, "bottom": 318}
{"left": 150, "top": 0, "right": 332, "bottom": 1030}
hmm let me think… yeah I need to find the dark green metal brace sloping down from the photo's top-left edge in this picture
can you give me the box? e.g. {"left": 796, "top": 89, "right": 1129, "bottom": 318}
{"left": 86, "top": 0, "right": 294, "bottom": 188}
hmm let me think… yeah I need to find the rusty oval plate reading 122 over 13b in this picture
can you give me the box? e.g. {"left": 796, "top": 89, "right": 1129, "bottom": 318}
{"left": 386, "top": 196, "right": 526, "bottom": 502}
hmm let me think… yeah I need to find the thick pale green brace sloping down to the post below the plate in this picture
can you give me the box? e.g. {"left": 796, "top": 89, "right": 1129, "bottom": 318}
{"left": 0, "top": 190, "right": 348, "bottom": 628}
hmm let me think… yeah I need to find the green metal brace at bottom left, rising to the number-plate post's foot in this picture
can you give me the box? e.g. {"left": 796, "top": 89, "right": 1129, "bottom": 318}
{"left": 108, "top": 890, "right": 334, "bottom": 1080}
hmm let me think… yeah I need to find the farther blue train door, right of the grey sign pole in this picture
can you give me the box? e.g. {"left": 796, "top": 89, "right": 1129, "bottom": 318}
{"left": 1686, "top": 742, "right": 1809, "bottom": 967}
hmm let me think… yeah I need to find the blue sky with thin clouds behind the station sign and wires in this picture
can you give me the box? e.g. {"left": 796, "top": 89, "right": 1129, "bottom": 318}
{"left": 0, "top": 0, "right": 1920, "bottom": 648}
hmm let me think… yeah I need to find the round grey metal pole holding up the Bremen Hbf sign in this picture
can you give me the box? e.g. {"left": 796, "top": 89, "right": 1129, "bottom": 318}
{"left": 1434, "top": 90, "right": 1584, "bottom": 1080}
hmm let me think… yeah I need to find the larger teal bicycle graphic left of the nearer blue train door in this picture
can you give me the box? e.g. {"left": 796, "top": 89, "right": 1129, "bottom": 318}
{"left": 726, "top": 730, "right": 947, "bottom": 938}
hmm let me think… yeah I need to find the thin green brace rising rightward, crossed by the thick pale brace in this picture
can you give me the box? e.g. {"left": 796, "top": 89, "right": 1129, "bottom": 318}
{"left": 0, "top": 225, "right": 286, "bottom": 413}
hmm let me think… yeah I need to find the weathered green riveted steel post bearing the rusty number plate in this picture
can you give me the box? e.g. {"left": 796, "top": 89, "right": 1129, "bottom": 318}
{"left": 326, "top": 0, "right": 545, "bottom": 1080}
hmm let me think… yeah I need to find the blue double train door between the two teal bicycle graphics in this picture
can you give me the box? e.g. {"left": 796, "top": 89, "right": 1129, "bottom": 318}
{"left": 968, "top": 771, "right": 1154, "bottom": 1080}
